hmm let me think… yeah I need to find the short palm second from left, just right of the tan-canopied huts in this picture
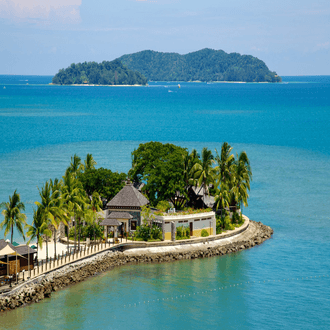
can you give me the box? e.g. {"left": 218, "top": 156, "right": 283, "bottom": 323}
{"left": 26, "top": 207, "right": 52, "bottom": 262}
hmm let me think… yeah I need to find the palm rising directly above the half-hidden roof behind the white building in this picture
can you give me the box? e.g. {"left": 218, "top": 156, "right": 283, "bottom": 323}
{"left": 192, "top": 148, "right": 215, "bottom": 200}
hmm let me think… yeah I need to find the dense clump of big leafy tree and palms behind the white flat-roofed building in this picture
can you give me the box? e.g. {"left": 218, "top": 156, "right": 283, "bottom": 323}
{"left": 128, "top": 142, "right": 252, "bottom": 215}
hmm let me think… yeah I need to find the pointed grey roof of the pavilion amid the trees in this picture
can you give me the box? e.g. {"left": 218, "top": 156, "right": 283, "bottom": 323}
{"left": 107, "top": 182, "right": 149, "bottom": 208}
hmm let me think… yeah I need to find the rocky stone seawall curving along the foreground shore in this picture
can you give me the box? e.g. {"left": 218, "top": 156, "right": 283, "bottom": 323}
{"left": 0, "top": 220, "right": 273, "bottom": 312}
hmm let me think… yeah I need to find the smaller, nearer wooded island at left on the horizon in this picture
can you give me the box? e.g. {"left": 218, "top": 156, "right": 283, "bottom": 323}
{"left": 52, "top": 60, "right": 148, "bottom": 85}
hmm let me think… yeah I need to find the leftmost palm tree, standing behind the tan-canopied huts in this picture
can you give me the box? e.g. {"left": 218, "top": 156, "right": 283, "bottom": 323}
{"left": 0, "top": 190, "right": 26, "bottom": 243}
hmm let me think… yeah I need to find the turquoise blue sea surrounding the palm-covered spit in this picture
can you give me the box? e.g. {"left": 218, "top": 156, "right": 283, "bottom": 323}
{"left": 0, "top": 76, "right": 330, "bottom": 329}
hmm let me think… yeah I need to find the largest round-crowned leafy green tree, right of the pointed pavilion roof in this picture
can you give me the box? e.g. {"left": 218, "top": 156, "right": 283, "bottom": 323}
{"left": 128, "top": 142, "right": 187, "bottom": 208}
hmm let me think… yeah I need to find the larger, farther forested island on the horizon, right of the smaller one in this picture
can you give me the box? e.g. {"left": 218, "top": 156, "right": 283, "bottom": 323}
{"left": 117, "top": 48, "right": 282, "bottom": 82}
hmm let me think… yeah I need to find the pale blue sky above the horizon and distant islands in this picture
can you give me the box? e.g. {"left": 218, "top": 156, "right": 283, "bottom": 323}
{"left": 0, "top": 0, "right": 330, "bottom": 76}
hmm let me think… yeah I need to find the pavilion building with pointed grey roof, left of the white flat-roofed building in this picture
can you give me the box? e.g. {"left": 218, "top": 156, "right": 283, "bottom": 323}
{"left": 104, "top": 180, "right": 149, "bottom": 232}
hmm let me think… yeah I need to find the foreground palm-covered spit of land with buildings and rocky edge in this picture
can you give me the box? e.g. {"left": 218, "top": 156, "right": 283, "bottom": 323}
{"left": 0, "top": 141, "right": 273, "bottom": 312}
